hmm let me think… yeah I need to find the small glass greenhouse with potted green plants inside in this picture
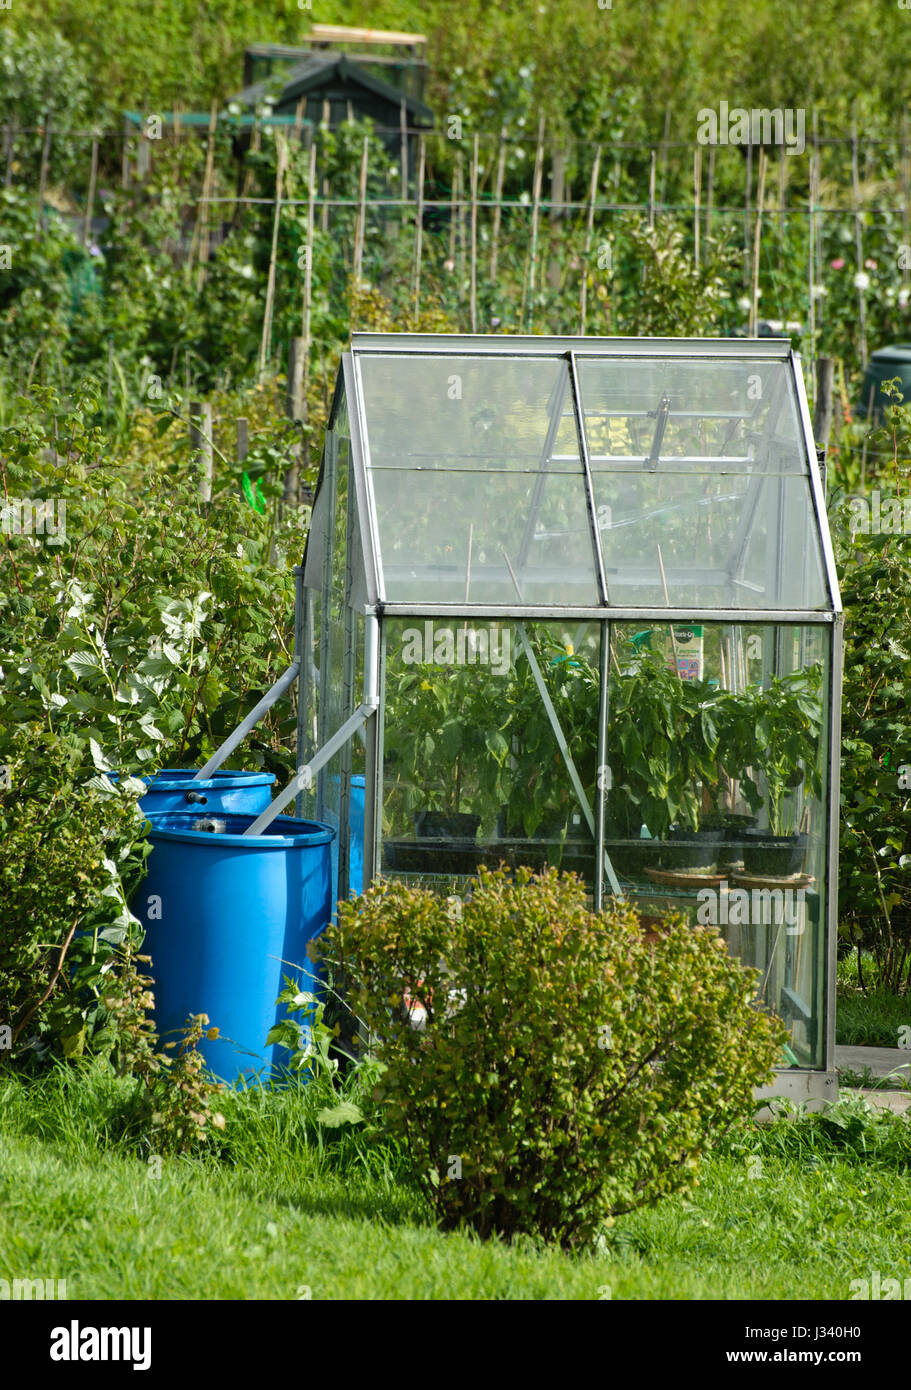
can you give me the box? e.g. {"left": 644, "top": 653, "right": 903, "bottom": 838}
{"left": 288, "top": 334, "right": 841, "bottom": 1098}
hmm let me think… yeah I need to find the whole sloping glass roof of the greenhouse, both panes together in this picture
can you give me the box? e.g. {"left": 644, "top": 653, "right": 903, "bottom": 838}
{"left": 315, "top": 334, "right": 839, "bottom": 613}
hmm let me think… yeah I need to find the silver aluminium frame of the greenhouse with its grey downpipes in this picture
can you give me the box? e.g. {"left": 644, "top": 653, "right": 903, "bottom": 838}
{"left": 200, "top": 334, "right": 843, "bottom": 1101}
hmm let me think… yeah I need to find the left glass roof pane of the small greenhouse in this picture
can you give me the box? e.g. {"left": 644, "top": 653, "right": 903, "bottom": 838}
{"left": 360, "top": 354, "right": 599, "bottom": 606}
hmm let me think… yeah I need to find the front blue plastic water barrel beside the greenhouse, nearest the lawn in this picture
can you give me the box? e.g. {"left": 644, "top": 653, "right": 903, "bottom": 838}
{"left": 132, "top": 808, "right": 335, "bottom": 1083}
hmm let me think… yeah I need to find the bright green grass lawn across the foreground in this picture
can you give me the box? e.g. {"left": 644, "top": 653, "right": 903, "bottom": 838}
{"left": 0, "top": 1072, "right": 911, "bottom": 1300}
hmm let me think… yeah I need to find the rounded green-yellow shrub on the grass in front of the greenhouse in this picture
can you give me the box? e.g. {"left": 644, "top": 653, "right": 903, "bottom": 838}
{"left": 324, "top": 869, "right": 784, "bottom": 1248}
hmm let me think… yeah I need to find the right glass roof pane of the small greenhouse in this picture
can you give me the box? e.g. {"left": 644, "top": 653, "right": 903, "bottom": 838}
{"left": 579, "top": 359, "right": 829, "bottom": 609}
